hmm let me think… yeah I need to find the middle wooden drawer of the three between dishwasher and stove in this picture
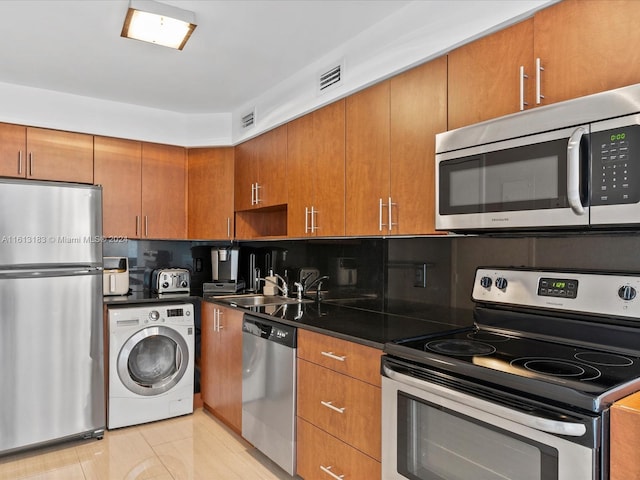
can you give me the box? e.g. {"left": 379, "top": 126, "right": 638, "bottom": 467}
{"left": 298, "top": 359, "right": 381, "bottom": 460}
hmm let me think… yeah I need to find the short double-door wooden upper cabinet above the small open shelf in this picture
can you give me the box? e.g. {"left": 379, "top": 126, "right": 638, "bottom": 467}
{"left": 235, "top": 125, "right": 287, "bottom": 211}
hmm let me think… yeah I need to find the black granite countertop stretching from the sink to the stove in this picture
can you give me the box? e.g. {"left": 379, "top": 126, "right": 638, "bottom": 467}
{"left": 204, "top": 296, "right": 473, "bottom": 349}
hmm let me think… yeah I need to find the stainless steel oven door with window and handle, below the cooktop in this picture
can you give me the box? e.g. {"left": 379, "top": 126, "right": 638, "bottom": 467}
{"left": 382, "top": 357, "right": 599, "bottom": 480}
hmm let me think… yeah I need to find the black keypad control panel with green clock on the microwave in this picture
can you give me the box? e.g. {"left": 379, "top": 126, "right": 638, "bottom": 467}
{"left": 591, "top": 125, "right": 640, "bottom": 205}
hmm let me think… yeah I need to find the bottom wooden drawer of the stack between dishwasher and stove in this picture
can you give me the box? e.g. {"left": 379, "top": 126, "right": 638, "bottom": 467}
{"left": 297, "top": 418, "right": 382, "bottom": 480}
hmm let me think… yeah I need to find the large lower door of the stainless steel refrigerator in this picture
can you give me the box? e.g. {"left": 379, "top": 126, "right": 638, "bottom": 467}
{"left": 0, "top": 270, "right": 106, "bottom": 453}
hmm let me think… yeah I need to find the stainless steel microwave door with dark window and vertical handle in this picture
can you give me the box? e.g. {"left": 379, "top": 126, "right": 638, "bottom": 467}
{"left": 436, "top": 125, "right": 589, "bottom": 231}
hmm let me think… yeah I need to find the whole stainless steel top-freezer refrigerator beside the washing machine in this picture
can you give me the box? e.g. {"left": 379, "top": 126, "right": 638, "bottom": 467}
{"left": 0, "top": 179, "right": 105, "bottom": 455}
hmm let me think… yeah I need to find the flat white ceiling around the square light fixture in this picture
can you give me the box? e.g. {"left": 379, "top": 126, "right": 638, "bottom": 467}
{"left": 0, "top": 0, "right": 411, "bottom": 114}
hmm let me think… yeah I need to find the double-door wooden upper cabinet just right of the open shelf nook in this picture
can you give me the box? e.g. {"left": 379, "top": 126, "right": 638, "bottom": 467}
{"left": 287, "top": 100, "right": 345, "bottom": 237}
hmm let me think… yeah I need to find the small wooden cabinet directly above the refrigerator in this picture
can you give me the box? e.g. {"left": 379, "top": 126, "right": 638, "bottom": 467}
{"left": 0, "top": 123, "right": 93, "bottom": 183}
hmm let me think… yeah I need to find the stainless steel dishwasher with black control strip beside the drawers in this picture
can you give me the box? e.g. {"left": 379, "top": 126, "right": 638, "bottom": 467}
{"left": 242, "top": 314, "right": 297, "bottom": 476}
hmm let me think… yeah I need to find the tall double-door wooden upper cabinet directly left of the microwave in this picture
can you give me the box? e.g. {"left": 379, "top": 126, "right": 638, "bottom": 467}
{"left": 346, "top": 57, "right": 447, "bottom": 235}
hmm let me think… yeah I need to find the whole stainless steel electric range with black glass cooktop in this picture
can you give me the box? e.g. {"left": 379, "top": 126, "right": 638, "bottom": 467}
{"left": 382, "top": 268, "right": 640, "bottom": 480}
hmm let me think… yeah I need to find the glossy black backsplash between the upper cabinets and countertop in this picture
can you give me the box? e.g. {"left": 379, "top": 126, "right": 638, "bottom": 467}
{"left": 104, "top": 232, "right": 640, "bottom": 310}
